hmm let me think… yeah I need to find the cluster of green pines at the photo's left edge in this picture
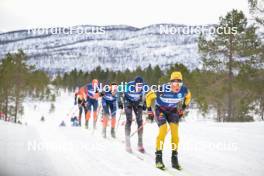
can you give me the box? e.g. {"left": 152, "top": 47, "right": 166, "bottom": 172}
{"left": 0, "top": 50, "right": 51, "bottom": 123}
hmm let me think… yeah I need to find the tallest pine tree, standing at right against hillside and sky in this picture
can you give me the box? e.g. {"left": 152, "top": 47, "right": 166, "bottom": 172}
{"left": 198, "top": 10, "right": 261, "bottom": 121}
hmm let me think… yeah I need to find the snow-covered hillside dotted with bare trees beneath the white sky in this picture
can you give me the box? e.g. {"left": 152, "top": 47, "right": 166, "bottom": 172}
{"left": 0, "top": 24, "right": 205, "bottom": 72}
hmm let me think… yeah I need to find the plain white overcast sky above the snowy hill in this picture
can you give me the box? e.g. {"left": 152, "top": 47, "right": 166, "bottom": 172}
{"left": 0, "top": 0, "right": 251, "bottom": 31}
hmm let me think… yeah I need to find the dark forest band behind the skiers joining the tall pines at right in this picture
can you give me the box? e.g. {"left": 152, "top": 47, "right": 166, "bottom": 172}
{"left": 53, "top": 10, "right": 264, "bottom": 121}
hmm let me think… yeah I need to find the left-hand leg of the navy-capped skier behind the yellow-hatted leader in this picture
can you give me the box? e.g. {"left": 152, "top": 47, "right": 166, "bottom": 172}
{"left": 125, "top": 103, "right": 132, "bottom": 152}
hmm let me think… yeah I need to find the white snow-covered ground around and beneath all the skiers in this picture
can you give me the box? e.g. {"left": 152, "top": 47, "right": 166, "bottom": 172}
{"left": 0, "top": 93, "right": 264, "bottom": 176}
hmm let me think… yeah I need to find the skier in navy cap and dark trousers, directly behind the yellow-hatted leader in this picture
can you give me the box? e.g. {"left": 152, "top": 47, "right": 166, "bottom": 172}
{"left": 119, "top": 76, "right": 147, "bottom": 153}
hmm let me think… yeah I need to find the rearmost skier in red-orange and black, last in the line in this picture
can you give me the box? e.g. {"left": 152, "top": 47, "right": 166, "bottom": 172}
{"left": 74, "top": 87, "right": 87, "bottom": 126}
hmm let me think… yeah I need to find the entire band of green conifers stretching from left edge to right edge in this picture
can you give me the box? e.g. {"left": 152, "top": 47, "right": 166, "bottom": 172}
{"left": 0, "top": 7, "right": 264, "bottom": 122}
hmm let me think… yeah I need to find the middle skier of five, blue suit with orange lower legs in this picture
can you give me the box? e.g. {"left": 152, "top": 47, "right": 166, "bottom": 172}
{"left": 101, "top": 82, "right": 118, "bottom": 138}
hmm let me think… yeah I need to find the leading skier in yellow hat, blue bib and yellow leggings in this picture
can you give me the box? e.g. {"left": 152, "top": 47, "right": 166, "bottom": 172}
{"left": 146, "top": 72, "right": 191, "bottom": 170}
